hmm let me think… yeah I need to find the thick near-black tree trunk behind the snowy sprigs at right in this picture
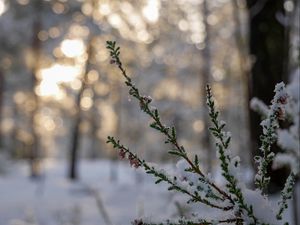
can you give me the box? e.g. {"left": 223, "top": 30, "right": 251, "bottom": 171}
{"left": 247, "top": 0, "right": 288, "bottom": 191}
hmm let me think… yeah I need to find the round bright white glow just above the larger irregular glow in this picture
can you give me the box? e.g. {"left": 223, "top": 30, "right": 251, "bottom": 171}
{"left": 61, "top": 39, "right": 85, "bottom": 58}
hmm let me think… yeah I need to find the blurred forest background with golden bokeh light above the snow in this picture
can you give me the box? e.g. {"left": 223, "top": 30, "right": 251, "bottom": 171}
{"left": 0, "top": 0, "right": 299, "bottom": 192}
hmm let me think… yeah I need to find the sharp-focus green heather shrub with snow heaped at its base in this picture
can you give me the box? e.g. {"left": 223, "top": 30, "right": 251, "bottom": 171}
{"left": 107, "top": 41, "right": 294, "bottom": 225}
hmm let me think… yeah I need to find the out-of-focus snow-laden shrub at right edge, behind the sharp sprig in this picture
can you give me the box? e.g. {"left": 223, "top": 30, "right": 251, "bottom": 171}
{"left": 251, "top": 72, "right": 300, "bottom": 177}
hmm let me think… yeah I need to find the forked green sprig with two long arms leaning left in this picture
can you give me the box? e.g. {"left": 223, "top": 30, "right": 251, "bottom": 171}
{"left": 107, "top": 41, "right": 233, "bottom": 210}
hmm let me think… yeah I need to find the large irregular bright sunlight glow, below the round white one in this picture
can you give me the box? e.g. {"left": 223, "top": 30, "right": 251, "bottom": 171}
{"left": 36, "top": 64, "right": 81, "bottom": 99}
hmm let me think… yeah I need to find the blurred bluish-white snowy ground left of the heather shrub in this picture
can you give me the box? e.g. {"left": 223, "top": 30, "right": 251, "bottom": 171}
{"left": 0, "top": 160, "right": 296, "bottom": 225}
